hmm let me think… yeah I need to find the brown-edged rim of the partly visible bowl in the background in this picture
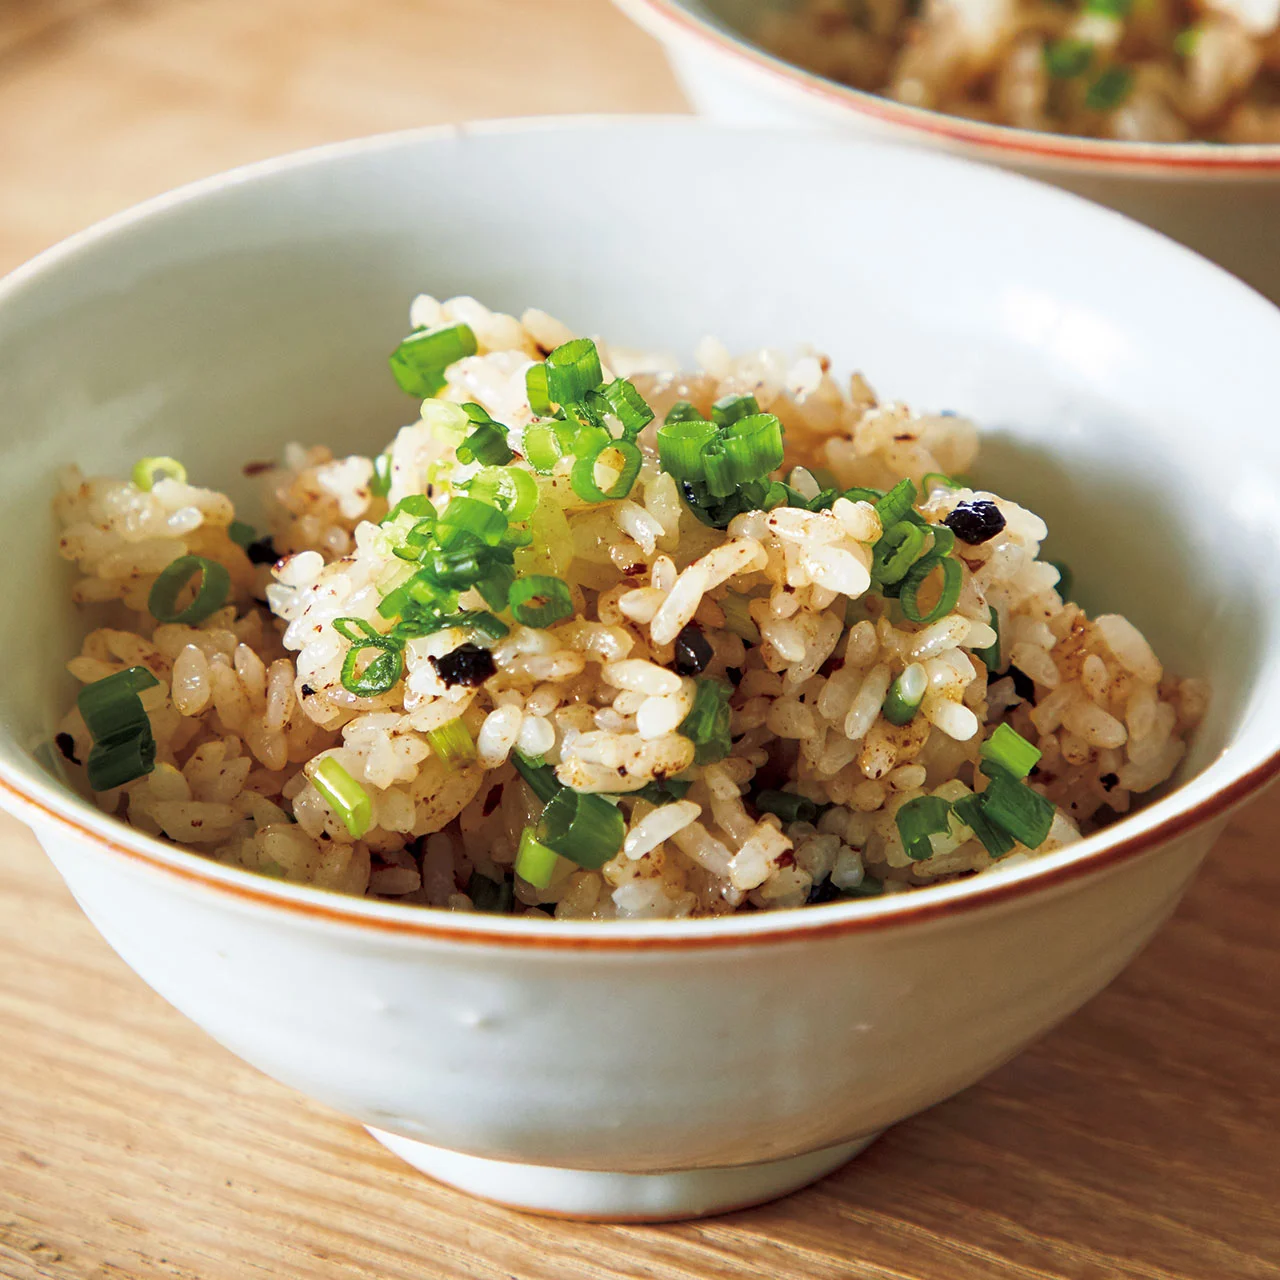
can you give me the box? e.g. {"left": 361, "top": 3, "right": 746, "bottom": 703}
{"left": 614, "top": 0, "right": 1280, "bottom": 175}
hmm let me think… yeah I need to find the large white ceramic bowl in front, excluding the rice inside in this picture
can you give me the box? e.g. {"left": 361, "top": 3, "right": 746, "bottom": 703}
{"left": 0, "top": 119, "right": 1280, "bottom": 1217}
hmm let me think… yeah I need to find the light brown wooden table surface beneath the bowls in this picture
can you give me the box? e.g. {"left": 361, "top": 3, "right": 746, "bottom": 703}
{"left": 0, "top": 0, "right": 1280, "bottom": 1280}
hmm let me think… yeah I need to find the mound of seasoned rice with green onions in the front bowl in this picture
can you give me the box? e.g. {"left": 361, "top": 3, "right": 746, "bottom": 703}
{"left": 55, "top": 297, "right": 1206, "bottom": 919}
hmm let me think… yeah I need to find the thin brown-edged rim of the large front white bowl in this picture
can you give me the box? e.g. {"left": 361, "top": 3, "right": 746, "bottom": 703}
{"left": 0, "top": 115, "right": 1280, "bottom": 952}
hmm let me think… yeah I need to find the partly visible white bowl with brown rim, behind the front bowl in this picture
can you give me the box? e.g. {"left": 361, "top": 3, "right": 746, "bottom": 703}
{"left": 614, "top": 0, "right": 1280, "bottom": 302}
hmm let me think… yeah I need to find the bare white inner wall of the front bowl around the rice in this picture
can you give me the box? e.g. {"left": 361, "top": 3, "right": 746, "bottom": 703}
{"left": 0, "top": 120, "right": 1280, "bottom": 860}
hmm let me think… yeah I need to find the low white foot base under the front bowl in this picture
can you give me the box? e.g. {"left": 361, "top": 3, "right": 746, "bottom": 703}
{"left": 369, "top": 1126, "right": 879, "bottom": 1222}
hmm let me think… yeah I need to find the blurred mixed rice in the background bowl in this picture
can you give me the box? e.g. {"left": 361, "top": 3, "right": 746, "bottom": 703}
{"left": 758, "top": 0, "right": 1280, "bottom": 143}
